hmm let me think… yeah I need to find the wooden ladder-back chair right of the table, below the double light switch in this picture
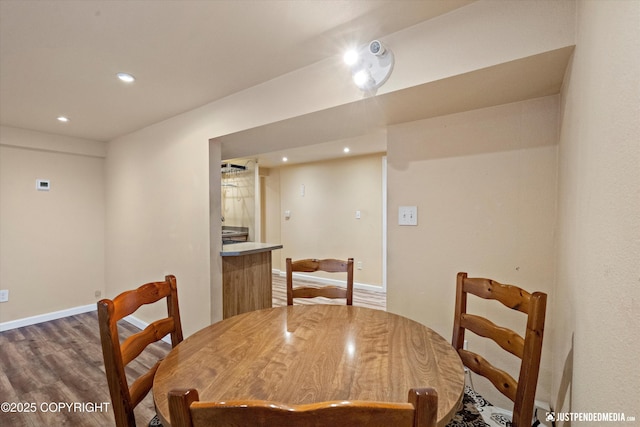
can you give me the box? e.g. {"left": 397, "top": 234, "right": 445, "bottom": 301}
{"left": 452, "top": 273, "right": 547, "bottom": 427}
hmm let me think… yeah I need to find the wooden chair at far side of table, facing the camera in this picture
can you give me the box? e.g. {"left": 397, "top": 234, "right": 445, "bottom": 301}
{"left": 287, "top": 258, "right": 353, "bottom": 305}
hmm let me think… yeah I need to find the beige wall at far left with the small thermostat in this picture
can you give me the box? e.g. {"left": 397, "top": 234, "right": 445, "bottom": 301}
{"left": 0, "top": 126, "right": 106, "bottom": 323}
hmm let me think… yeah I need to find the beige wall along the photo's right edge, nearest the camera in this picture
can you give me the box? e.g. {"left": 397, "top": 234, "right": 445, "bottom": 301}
{"left": 551, "top": 1, "right": 640, "bottom": 426}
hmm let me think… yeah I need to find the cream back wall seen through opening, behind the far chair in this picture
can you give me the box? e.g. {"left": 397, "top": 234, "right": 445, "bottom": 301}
{"left": 277, "top": 154, "right": 382, "bottom": 289}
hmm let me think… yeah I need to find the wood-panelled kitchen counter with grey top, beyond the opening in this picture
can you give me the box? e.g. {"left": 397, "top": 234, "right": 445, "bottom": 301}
{"left": 220, "top": 242, "right": 282, "bottom": 319}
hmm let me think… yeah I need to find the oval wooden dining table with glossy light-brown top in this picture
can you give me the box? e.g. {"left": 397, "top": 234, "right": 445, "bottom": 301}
{"left": 153, "top": 305, "right": 464, "bottom": 427}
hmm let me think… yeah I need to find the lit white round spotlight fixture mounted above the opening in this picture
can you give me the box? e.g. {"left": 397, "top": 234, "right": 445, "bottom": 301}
{"left": 343, "top": 40, "right": 395, "bottom": 92}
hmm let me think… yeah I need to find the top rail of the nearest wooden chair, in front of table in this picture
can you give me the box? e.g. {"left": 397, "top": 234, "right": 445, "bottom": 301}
{"left": 169, "top": 387, "right": 438, "bottom": 427}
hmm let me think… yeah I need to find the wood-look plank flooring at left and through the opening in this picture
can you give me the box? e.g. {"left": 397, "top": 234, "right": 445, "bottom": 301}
{"left": 0, "top": 275, "right": 386, "bottom": 427}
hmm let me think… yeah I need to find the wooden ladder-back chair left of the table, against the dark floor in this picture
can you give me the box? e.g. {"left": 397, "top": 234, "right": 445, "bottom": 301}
{"left": 98, "top": 275, "right": 182, "bottom": 427}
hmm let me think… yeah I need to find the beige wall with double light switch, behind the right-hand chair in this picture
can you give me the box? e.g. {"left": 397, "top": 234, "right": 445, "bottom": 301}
{"left": 387, "top": 96, "right": 558, "bottom": 407}
